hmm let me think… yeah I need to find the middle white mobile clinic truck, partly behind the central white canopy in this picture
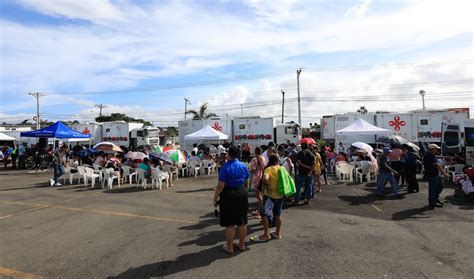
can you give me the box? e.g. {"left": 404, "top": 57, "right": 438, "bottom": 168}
{"left": 178, "top": 117, "right": 301, "bottom": 150}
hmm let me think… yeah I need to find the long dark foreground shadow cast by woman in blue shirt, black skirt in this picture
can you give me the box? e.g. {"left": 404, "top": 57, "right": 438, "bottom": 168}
{"left": 108, "top": 246, "right": 245, "bottom": 278}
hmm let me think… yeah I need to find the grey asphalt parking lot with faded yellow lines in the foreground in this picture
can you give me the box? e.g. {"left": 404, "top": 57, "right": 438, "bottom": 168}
{"left": 0, "top": 169, "right": 474, "bottom": 278}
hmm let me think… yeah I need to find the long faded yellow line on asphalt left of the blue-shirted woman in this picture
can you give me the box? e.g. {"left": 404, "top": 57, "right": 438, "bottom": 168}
{"left": 0, "top": 201, "right": 198, "bottom": 224}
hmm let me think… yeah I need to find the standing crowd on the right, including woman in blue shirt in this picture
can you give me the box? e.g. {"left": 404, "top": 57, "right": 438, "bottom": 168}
{"left": 214, "top": 142, "right": 473, "bottom": 253}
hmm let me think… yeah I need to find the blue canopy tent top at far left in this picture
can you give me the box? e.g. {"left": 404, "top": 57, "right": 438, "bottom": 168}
{"left": 20, "top": 121, "right": 91, "bottom": 149}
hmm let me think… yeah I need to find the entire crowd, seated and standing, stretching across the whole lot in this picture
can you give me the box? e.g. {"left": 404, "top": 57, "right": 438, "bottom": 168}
{"left": 0, "top": 137, "right": 474, "bottom": 253}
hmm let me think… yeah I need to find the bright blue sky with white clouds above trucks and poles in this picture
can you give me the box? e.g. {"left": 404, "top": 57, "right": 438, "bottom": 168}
{"left": 0, "top": 0, "right": 474, "bottom": 126}
